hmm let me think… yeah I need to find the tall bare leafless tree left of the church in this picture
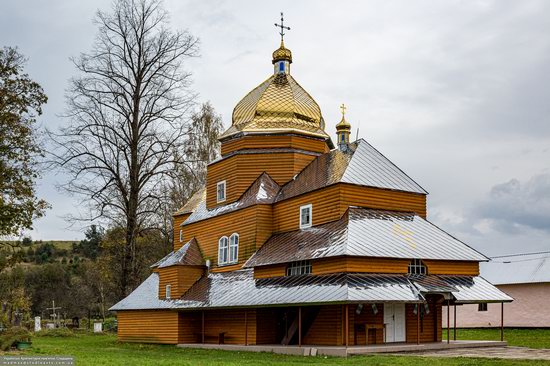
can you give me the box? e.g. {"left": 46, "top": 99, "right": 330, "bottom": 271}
{"left": 50, "top": 0, "right": 198, "bottom": 296}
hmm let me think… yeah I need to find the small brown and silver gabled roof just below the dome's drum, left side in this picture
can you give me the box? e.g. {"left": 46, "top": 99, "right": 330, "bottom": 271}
{"left": 182, "top": 172, "right": 280, "bottom": 225}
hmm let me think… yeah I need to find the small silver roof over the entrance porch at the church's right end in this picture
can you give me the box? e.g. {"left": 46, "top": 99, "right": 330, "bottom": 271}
{"left": 439, "top": 276, "right": 514, "bottom": 304}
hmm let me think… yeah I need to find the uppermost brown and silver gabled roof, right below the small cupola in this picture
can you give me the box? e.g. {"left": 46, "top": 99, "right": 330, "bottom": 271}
{"left": 277, "top": 139, "right": 428, "bottom": 201}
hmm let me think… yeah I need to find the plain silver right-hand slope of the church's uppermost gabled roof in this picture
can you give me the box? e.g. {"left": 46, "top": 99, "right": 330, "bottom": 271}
{"left": 341, "top": 139, "right": 428, "bottom": 194}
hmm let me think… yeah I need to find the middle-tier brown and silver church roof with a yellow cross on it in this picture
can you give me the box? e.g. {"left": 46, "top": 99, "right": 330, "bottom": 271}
{"left": 248, "top": 207, "right": 488, "bottom": 268}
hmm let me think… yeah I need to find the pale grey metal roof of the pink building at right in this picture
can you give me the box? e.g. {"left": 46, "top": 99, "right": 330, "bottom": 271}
{"left": 480, "top": 253, "right": 550, "bottom": 285}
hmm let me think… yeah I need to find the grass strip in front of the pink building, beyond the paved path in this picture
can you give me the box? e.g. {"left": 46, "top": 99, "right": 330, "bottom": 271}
{"left": 443, "top": 328, "right": 550, "bottom": 348}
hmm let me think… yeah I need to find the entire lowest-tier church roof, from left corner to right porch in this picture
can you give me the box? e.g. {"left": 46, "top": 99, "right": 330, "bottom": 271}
{"left": 110, "top": 270, "right": 512, "bottom": 311}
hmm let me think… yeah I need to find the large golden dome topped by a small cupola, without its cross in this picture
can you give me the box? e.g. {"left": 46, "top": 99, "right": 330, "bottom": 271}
{"left": 220, "top": 42, "right": 332, "bottom": 145}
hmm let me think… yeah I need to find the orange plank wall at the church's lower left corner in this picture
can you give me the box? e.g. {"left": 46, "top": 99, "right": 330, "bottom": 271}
{"left": 117, "top": 310, "right": 180, "bottom": 344}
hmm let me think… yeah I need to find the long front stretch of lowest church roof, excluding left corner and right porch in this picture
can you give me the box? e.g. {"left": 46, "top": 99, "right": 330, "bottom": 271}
{"left": 182, "top": 270, "right": 424, "bottom": 308}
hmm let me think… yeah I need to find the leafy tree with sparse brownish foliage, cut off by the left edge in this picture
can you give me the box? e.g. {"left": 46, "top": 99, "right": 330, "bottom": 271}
{"left": 0, "top": 47, "right": 48, "bottom": 237}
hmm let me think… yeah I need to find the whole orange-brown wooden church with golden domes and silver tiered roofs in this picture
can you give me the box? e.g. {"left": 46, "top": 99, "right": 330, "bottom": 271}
{"left": 111, "top": 23, "right": 512, "bottom": 346}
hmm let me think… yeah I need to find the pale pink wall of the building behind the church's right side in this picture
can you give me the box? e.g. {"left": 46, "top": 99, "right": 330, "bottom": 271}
{"left": 443, "top": 283, "right": 550, "bottom": 328}
